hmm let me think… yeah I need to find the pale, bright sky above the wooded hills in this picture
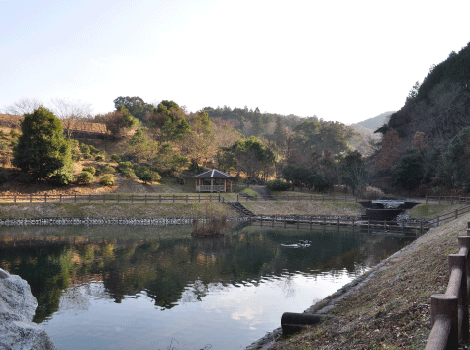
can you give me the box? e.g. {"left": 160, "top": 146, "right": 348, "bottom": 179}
{"left": 0, "top": 0, "right": 470, "bottom": 124}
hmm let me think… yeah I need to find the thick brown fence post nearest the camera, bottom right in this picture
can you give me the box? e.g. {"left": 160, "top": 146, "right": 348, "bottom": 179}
{"left": 428, "top": 294, "right": 459, "bottom": 349}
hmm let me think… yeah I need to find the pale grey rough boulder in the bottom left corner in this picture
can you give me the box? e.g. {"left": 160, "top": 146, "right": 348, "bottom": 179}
{"left": 0, "top": 269, "right": 56, "bottom": 350}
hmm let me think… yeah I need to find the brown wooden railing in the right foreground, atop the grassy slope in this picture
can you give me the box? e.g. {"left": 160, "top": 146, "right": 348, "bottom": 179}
{"left": 425, "top": 223, "right": 470, "bottom": 350}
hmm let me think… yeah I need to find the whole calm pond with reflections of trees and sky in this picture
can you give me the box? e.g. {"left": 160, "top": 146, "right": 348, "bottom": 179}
{"left": 0, "top": 226, "right": 410, "bottom": 350}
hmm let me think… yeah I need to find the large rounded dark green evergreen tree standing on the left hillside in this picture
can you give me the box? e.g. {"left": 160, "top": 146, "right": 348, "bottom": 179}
{"left": 13, "top": 107, "right": 73, "bottom": 184}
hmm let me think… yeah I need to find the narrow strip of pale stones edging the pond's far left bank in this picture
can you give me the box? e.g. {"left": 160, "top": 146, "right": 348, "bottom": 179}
{"left": 0, "top": 217, "right": 247, "bottom": 226}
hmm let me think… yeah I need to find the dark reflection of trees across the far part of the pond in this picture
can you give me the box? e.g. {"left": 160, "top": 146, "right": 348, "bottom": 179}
{"left": 0, "top": 227, "right": 414, "bottom": 322}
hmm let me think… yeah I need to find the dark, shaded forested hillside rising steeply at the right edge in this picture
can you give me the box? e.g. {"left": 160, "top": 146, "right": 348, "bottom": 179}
{"left": 374, "top": 43, "right": 470, "bottom": 194}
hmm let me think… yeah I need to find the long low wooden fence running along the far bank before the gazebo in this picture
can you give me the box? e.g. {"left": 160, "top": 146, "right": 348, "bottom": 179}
{"left": 0, "top": 193, "right": 358, "bottom": 203}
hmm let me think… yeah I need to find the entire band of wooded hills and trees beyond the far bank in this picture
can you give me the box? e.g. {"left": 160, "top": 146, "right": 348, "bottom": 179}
{"left": 0, "top": 45, "right": 470, "bottom": 195}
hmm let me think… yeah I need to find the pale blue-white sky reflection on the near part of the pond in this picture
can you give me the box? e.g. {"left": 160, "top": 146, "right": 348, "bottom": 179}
{"left": 45, "top": 271, "right": 352, "bottom": 349}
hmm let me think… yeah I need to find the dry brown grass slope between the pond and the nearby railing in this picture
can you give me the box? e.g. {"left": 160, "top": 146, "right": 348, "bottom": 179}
{"left": 271, "top": 214, "right": 470, "bottom": 349}
